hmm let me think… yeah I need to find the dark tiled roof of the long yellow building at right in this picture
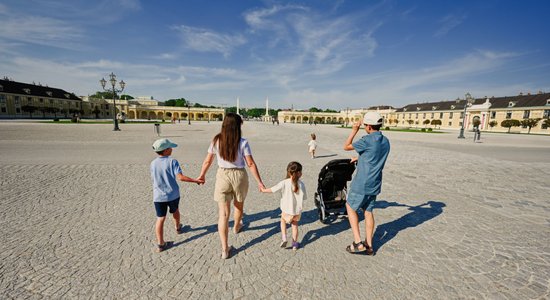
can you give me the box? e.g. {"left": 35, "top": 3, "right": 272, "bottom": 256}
{"left": 396, "top": 93, "right": 550, "bottom": 113}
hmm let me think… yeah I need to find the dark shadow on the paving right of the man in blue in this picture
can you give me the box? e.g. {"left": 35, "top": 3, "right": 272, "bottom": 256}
{"left": 372, "top": 200, "right": 446, "bottom": 252}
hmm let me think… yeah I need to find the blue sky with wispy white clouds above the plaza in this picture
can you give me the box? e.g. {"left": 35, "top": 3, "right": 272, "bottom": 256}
{"left": 0, "top": 0, "right": 550, "bottom": 109}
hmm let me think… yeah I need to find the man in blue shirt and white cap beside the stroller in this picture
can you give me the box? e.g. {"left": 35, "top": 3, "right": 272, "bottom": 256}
{"left": 344, "top": 112, "right": 390, "bottom": 255}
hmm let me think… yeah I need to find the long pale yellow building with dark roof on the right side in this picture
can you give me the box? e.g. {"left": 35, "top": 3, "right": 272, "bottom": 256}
{"left": 277, "top": 92, "right": 550, "bottom": 134}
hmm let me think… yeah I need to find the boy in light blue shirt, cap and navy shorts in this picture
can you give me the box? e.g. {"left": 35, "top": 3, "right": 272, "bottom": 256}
{"left": 150, "top": 139, "right": 202, "bottom": 252}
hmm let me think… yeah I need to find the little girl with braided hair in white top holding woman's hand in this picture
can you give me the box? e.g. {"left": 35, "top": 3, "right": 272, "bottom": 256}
{"left": 261, "top": 161, "right": 307, "bottom": 250}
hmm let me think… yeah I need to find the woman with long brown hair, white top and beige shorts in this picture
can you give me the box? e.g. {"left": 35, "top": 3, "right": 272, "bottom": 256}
{"left": 197, "top": 113, "right": 265, "bottom": 258}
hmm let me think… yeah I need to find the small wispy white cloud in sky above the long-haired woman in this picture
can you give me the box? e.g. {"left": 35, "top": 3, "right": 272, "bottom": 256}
{"left": 173, "top": 25, "right": 246, "bottom": 58}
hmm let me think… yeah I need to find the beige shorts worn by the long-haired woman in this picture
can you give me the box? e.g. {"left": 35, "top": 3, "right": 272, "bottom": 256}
{"left": 214, "top": 168, "right": 248, "bottom": 202}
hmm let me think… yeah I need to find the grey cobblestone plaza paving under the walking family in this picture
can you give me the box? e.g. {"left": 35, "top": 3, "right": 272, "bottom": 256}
{"left": 0, "top": 121, "right": 550, "bottom": 299}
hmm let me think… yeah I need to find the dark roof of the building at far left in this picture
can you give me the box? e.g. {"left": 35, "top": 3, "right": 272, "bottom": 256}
{"left": 0, "top": 79, "right": 82, "bottom": 101}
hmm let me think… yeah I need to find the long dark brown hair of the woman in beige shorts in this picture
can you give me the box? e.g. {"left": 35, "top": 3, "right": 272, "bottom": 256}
{"left": 212, "top": 113, "right": 243, "bottom": 162}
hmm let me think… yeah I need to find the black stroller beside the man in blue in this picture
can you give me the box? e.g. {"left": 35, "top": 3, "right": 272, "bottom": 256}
{"left": 315, "top": 159, "right": 355, "bottom": 223}
